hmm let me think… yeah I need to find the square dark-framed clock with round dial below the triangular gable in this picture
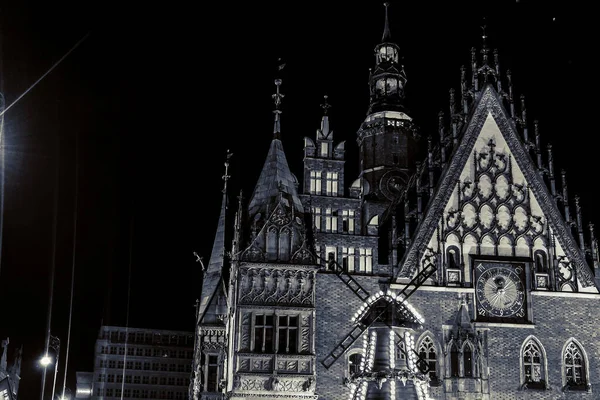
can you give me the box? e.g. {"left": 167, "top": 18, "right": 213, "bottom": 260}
{"left": 475, "top": 261, "right": 527, "bottom": 322}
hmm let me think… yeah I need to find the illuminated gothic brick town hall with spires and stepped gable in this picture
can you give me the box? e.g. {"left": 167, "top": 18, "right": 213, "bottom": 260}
{"left": 190, "top": 5, "right": 600, "bottom": 400}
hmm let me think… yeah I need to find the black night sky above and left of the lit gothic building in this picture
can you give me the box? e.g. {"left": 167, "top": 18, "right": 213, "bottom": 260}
{"left": 0, "top": 0, "right": 600, "bottom": 400}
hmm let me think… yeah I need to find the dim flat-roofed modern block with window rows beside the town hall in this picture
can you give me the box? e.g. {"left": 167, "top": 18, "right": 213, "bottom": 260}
{"left": 76, "top": 326, "right": 194, "bottom": 399}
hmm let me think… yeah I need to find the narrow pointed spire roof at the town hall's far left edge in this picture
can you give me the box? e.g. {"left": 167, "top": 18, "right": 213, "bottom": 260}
{"left": 198, "top": 150, "right": 233, "bottom": 322}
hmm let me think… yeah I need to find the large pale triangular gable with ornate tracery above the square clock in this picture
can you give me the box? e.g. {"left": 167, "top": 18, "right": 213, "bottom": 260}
{"left": 401, "top": 85, "right": 598, "bottom": 293}
